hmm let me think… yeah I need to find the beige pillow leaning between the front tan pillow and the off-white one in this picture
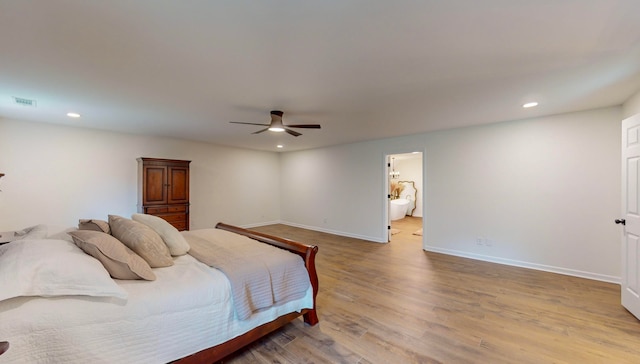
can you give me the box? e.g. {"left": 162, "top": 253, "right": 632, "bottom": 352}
{"left": 109, "top": 215, "right": 173, "bottom": 268}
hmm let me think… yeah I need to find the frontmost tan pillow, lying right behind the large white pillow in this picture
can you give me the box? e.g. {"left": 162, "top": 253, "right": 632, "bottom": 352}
{"left": 69, "top": 230, "right": 156, "bottom": 281}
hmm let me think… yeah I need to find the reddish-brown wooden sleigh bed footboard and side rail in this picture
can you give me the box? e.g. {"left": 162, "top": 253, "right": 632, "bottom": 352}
{"left": 173, "top": 223, "right": 318, "bottom": 364}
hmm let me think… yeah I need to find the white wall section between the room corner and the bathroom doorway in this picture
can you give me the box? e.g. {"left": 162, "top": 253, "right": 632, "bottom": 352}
{"left": 281, "top": 143, "right": 384, "bottom": 241}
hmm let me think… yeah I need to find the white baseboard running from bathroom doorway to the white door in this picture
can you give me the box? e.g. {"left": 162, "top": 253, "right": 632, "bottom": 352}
{"left": 423, "top": 245, "right": 621, "bottom": 284}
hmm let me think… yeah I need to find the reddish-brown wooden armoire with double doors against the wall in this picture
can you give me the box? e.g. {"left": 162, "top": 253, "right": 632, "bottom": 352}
{"left": 138, "top": 157, "right": 191, "bottom": 230}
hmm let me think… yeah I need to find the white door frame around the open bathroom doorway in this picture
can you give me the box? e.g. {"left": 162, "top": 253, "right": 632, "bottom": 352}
{"left": 381, "top": 147, "right": 427, "bottom": 250}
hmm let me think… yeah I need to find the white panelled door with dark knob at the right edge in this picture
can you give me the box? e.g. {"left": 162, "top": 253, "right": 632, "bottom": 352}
{"left": 616, "top": 114, "right": 640, "bottom": 319}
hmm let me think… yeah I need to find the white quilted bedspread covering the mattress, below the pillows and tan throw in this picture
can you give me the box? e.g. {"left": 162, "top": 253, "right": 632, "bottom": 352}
{"left": 0, "top": 255, "right": 313, "bottom": 363}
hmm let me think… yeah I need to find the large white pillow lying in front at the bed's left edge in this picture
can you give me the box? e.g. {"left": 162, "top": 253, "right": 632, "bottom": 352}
{"left": 0, "top": 239, "right": 127, "bottom": 301}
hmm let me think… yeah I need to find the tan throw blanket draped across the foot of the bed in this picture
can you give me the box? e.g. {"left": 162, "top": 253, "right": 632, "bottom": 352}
{"left": 182, "top": 229, "right": 311, "bottom": 320}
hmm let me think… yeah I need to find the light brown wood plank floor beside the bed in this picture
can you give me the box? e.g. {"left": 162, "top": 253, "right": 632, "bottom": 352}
{"left": 225, "top": 219, "right": 640, "bottom": 364}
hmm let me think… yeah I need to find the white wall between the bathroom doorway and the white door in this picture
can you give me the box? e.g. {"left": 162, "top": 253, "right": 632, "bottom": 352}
{"left": 427, "top": 108, "right": 621, "bottom": 281}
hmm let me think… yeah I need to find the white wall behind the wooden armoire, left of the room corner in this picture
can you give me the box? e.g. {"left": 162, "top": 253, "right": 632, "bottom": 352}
{"left": 0, "top": 119, "right": 280, "bottom": 231}
